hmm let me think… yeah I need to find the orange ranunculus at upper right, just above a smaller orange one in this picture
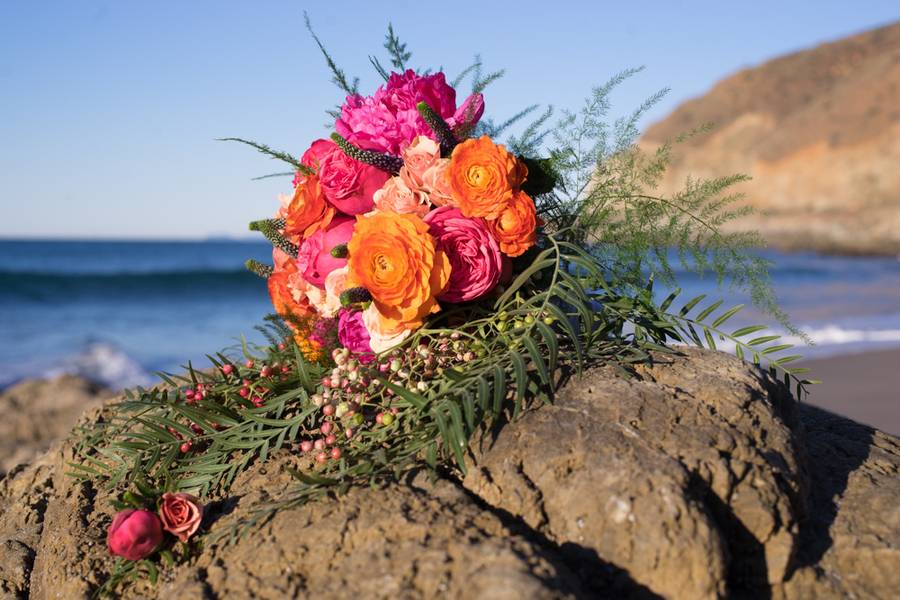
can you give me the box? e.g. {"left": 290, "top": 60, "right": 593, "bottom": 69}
{"left": 446, "top": 135, "right": 528, "bottom": 219}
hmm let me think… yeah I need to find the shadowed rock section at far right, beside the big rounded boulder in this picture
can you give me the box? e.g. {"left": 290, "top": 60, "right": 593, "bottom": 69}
{"left": 775, "top": 405, "right": 900, "bottom": 599}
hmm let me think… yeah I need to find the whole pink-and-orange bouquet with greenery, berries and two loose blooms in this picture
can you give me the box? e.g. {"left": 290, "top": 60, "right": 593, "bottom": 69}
{"left": 72, "top": 19, "right": 809, "bottom": 592}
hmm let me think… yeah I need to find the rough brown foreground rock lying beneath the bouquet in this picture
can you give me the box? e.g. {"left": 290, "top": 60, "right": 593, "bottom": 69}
{"left": 0, "top": 350, "right": 900, "bottom": 600}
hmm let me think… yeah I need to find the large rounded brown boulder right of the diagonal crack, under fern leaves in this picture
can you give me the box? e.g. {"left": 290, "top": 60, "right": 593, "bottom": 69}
{"left": 464, "top": 351, "right": 806, "bottom": 598}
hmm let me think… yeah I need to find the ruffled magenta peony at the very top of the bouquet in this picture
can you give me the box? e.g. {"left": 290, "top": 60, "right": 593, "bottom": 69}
{"left": 335, "top": 70, "right": 484, "bottom": 156}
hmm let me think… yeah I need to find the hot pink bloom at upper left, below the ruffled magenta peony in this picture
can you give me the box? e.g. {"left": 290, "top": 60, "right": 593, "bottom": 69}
{"left": 314, "top": 140, "right": 390, "bottom": 215}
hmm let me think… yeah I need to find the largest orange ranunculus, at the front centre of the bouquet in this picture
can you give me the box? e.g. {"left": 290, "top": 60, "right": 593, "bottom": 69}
{"left": 347, "top": 212, "right": 450, "bottom": 330}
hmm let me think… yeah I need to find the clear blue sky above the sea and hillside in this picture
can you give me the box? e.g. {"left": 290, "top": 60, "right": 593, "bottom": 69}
{"left": 0, "top": 0, "right": 900, "bottom": 238}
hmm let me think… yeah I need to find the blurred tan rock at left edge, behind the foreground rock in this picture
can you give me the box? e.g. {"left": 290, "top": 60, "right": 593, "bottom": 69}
{"left": 0, "top": 375, "right": 112, "bottom": 476}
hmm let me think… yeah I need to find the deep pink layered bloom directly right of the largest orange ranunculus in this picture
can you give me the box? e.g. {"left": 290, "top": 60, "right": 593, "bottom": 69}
{"left": 425, "top": 206, "right": 503, "bottom": 302}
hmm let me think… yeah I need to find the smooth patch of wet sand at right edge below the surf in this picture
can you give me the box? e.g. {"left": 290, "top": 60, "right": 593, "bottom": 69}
{"left": 798, "top": 350, "right": 900, "bottom": 435}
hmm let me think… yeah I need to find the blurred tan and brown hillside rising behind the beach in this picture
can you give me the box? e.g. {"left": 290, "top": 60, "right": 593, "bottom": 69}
{"left": 642, "top": 23, "right": 900, "bottom": 253}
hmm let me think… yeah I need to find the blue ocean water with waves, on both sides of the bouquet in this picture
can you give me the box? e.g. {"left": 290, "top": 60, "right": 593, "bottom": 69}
{"left": 0, "top": 240, "right": 900, "bottom": 388}
